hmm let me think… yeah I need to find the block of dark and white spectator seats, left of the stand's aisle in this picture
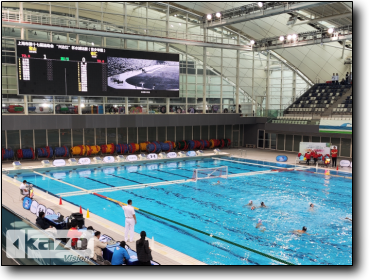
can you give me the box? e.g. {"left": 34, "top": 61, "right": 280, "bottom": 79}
{"left": 286, "top": 84, "right": 352, "bottom": 114}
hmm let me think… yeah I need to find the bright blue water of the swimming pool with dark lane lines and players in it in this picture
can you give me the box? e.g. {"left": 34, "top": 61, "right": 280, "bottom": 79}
{"left": 12, "top": 158, "right": 352, "bottom": 265}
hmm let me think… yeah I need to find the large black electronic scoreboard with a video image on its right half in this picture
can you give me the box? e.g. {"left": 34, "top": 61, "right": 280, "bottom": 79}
{"left": 16, "top": 40, "right": 180, "bottom": 97}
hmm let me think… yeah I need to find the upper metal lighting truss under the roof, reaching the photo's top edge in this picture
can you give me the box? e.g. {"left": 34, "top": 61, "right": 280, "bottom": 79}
{"left": 203, "top": 2, "right": 335, "bottom": 28}
